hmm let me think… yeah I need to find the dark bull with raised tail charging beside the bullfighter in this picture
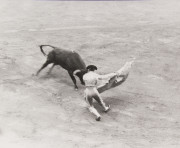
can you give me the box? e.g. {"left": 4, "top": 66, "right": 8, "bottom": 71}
{"left": 36, "top": 45, "right": 86, "bottom": 89}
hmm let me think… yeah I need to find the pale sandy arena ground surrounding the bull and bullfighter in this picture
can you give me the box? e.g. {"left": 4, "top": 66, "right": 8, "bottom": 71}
{"left": 0, "top": 0, "right": 180, "bottom": 148}
